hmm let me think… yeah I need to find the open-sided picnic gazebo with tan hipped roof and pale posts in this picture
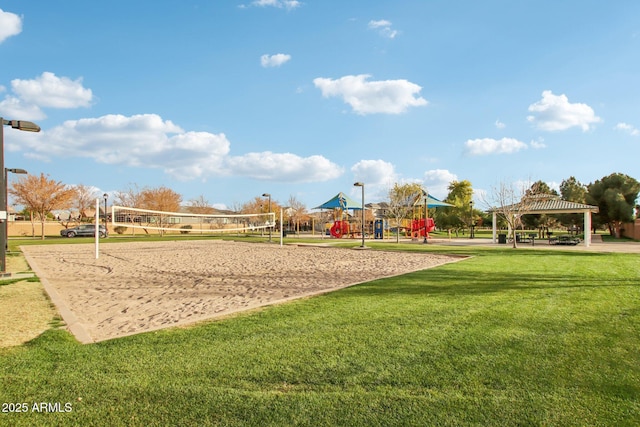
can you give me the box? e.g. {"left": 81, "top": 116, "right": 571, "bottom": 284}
{"left": 491, "top": 194, "right": 598, "bottom": 247}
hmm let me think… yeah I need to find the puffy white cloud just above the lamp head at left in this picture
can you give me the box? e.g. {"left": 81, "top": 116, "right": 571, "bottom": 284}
{"left": 0, "top": 71, "right": 93, "bottom": 120}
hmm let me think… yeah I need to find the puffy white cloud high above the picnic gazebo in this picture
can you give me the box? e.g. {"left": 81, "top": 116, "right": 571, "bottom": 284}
{"left": 527, "top": 90, "right": 602, "bottom": 132}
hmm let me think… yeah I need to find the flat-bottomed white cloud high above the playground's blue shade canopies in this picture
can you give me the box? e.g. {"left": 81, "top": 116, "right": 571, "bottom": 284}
{"left": 313, "top": 74, "right": 427, "bottom": 115}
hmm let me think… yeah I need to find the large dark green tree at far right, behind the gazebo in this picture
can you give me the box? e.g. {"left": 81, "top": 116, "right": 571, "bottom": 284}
{"left": 586, "top": 173, "right": 640, "bottom": 238}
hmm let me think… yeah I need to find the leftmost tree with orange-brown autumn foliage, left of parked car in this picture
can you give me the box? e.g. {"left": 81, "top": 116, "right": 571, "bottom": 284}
{"left": 9, "top": 173, "right": 76, "bottom": 240}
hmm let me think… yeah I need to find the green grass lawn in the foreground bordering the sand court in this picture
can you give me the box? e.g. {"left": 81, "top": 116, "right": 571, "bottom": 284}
{"left": 0, "top": 242, "right": 640, "bottom": 426}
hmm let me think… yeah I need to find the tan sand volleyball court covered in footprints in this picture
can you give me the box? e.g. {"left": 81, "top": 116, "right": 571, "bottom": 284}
{"left": 22, "top": 240, "right": 459, "bottom": 343}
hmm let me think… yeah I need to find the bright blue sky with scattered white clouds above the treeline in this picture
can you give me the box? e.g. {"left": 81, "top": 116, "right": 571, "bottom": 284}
{"left": 0, "top": 0, "right": 640, "bottom": 208}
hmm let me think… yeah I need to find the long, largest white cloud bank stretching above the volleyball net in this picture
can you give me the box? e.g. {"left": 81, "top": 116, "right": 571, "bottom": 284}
{"left": 7, "top": 114, "right": 343, "bottom": 186}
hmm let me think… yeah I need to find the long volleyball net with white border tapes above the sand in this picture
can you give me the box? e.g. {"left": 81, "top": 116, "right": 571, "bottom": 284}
{"left": 111, "top": 205, "right": 276, "bottom": 234}
